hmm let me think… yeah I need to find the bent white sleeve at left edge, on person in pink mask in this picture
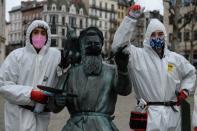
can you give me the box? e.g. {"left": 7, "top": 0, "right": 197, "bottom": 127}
{"left": 0, "top": 50, "right": 33, "bottom": 105}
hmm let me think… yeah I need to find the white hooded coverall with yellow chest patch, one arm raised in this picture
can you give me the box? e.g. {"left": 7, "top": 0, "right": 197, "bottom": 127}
{"left": 112, "top": 16, "right": 196, "bottom": 131}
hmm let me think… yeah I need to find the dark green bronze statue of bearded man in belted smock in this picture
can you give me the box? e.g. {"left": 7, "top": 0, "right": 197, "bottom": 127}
{"left": 49, "top": 27, "right": 131, "bottom": 131}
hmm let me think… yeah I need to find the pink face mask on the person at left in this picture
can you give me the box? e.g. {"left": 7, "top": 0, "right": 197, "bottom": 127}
{"left": 32, "top": 35, "right": 46, "bottom": 49}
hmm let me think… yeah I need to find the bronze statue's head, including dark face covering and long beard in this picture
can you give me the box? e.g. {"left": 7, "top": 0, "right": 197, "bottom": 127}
{"left": 79, "top": 27, "right": 104, "bottom": 75}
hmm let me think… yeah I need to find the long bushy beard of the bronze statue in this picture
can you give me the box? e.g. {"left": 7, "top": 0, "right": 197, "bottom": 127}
{"left": 82, "top": 55, "right": 102, "bottom": 75}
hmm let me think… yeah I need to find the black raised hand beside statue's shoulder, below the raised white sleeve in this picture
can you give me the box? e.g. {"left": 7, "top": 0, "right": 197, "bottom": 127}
{"left": 115, "top": 51, "right": 129, "bottom": 73}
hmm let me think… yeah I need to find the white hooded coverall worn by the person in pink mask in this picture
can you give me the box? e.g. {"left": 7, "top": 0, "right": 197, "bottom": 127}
{"left": 0, "top": 20, "right": 61, "bottom": 131}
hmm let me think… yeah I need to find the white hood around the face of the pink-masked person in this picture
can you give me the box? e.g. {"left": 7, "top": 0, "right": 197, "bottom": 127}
{"left": 26, "top": 20, "right": 51, "bottom": 52}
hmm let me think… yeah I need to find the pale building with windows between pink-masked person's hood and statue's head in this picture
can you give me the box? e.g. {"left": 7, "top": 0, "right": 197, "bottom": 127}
{"left": 42, "top": 0, "right": 87, "bottom": 49}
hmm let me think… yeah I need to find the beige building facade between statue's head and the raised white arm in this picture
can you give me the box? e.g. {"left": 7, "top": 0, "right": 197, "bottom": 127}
{"left": 84, "top": 0, "right": 118, "bottom": 56}
